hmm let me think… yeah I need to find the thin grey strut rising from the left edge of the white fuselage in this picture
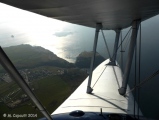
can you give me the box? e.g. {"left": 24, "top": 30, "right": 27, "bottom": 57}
{"left": 87, "top": 23, "right": 102, "bottom": 93}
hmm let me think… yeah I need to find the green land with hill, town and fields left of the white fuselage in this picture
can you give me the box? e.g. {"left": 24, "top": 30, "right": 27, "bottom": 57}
{"left": 0, "top": 45, "right": 87, "bottom": 120}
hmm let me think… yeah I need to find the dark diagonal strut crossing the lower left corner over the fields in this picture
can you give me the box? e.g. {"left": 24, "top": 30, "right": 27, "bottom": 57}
{"left": 0, "top": 47, "right": 52, "bottom": 120}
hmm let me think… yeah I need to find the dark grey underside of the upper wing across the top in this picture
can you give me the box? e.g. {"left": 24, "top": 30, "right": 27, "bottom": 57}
{"left": 0, "top": 0, "right": 159, "bottom": 29}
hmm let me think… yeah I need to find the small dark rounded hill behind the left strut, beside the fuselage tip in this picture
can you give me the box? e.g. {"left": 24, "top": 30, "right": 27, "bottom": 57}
{"left": 75, "top": 51, "right": 105, "bottom": 68}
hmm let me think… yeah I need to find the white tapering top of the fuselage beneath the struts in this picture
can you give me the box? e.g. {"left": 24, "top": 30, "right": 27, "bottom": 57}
{"left": 52, "top": 59, "right": 142, "bottom": 115}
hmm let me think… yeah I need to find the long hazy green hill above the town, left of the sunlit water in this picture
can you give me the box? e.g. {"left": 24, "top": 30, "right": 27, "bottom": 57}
{"left": 3, "top": 44, "right": 74, "bottom": 69}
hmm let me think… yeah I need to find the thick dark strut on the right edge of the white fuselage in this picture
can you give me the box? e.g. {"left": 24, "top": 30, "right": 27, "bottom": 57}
{"left": 119, "top": 20, "right": 141, "bottom": 95}
